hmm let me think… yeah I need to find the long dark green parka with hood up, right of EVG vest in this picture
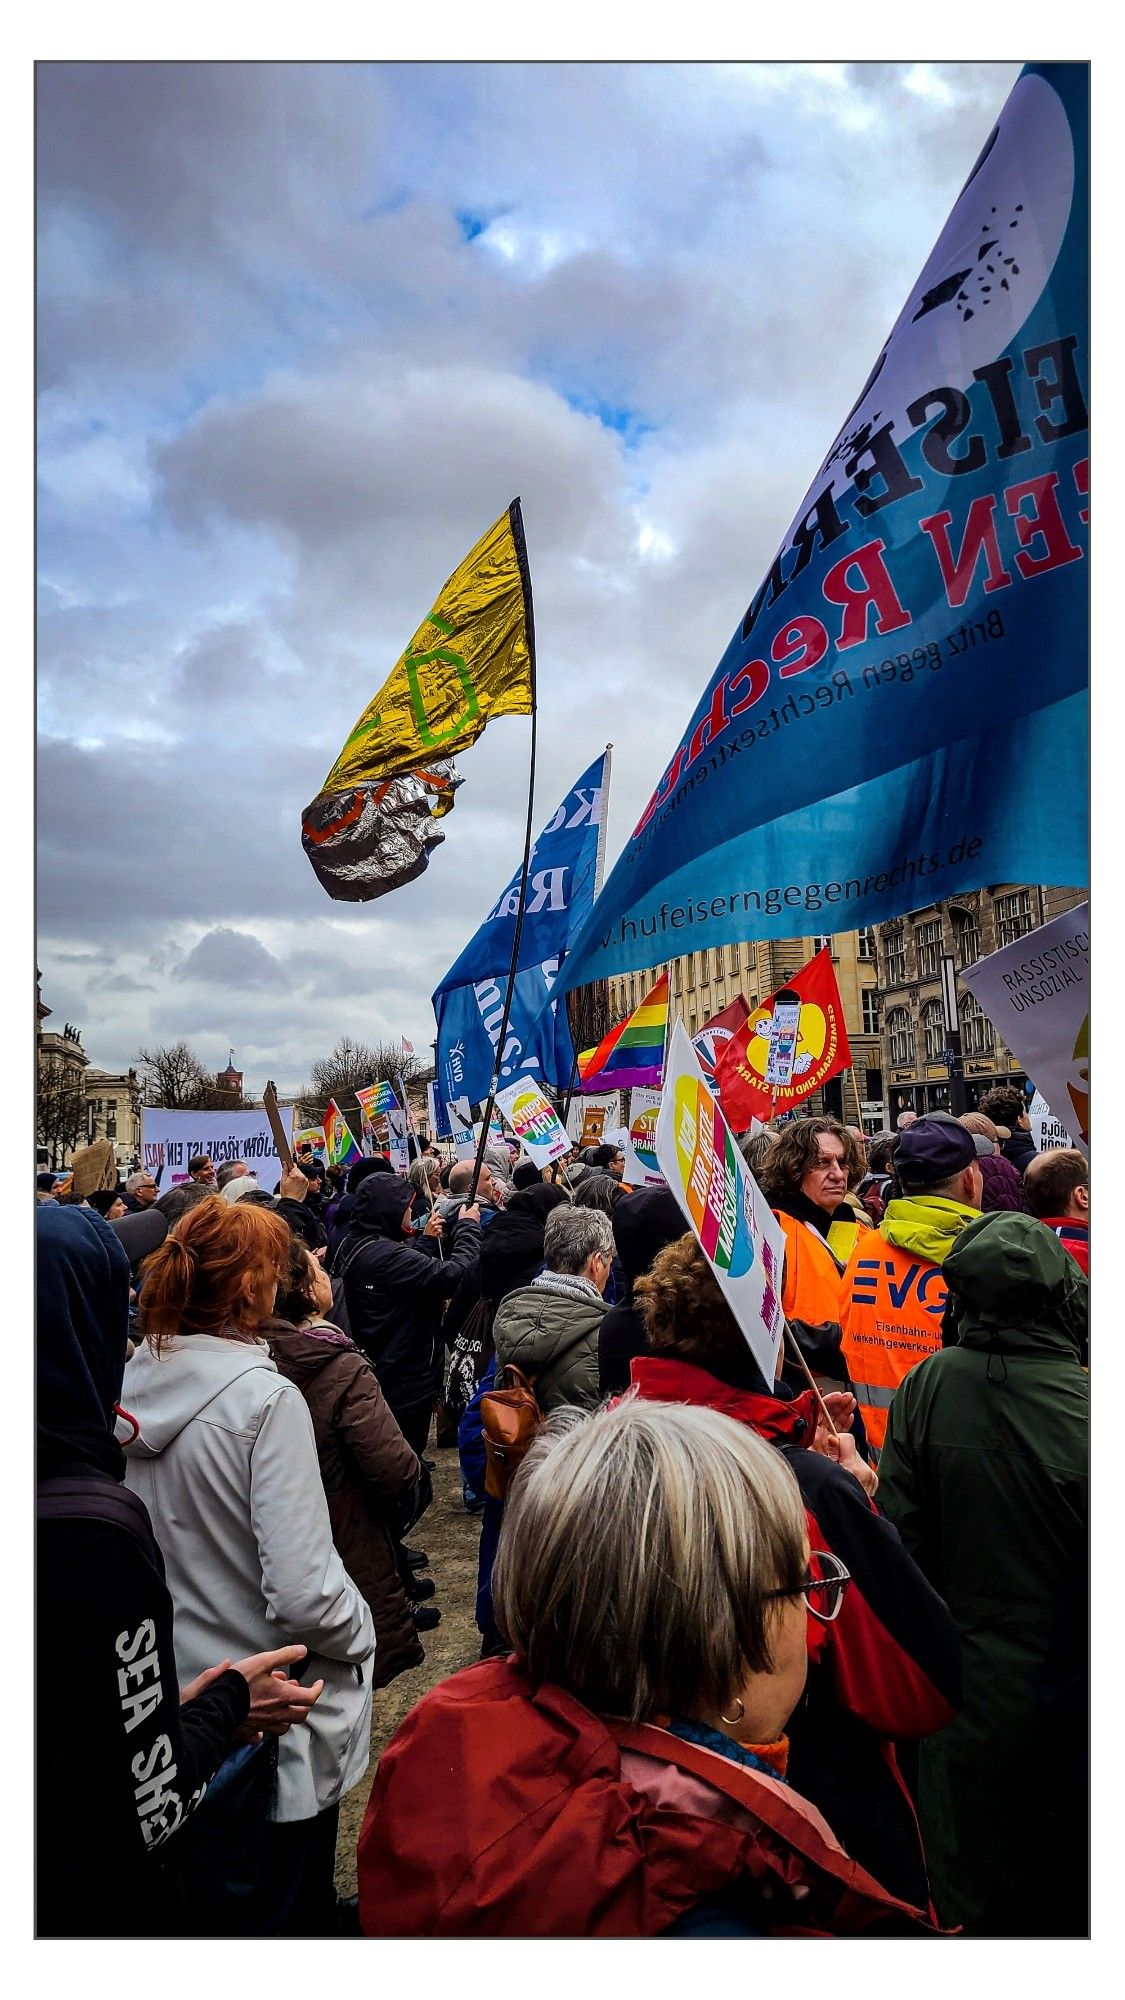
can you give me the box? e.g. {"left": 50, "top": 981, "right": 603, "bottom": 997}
{"left": 879, "top": 1214, "right": 1089, "bottom": 1936}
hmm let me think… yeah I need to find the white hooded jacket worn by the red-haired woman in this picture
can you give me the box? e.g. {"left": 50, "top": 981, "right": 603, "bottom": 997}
{"left": 122, "top": 1334, "right": 374, "bottom": 1820}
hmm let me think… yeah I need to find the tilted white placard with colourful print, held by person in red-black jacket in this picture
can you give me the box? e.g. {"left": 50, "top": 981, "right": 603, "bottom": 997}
{"left": 657, "top": 1020, "right": 785, "bottom": 1386}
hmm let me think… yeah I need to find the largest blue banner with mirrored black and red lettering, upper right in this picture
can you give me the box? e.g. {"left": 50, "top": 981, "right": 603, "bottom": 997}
{"left": 558, "top": 62, "right": 1089, "bottom": 988}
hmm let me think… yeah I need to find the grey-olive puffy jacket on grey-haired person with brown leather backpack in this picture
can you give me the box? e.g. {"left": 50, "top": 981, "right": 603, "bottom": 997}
{"left": 492, "top": 1270, "right": 607, "bottom": 1414}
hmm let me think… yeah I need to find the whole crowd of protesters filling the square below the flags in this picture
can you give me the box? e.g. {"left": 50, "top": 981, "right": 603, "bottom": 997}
{"left": 36, "top": 1092, "right": 1089, "bottom": 1938}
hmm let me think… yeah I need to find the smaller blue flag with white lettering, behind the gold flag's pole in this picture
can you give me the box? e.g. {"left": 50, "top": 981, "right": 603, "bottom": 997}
{"left": 434, "top": 752, "right": 609, "bottom": 1104}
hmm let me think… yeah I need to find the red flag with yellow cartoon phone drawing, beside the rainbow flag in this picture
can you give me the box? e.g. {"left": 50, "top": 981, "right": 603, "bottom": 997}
{"left": 717, "top": 946, "right": 851, "bottom": 1132}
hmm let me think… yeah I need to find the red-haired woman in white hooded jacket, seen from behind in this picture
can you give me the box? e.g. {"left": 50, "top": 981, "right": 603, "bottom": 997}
{"left": 122, "top": 1196, "right": 374, "bottom": 1936}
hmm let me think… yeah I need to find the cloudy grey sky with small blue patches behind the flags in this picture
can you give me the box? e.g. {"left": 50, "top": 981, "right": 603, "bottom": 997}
{"left": 38, "top": 62, "right": 1019, "bottom": 1088}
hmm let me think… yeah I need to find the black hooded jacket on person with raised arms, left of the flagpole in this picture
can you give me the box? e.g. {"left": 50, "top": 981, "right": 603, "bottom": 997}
{"left": 332, "top": 1174, "right": 480, "bottom": 1414}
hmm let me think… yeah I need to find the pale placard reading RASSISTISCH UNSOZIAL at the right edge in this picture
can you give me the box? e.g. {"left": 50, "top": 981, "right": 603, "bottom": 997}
{"left": 957, "top": 902, "right": 1089, "bottom": 1152}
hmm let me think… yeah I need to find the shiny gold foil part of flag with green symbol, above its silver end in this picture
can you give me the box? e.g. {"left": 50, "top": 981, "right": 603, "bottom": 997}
{"left": 322, "top": 500, "right": 532, "bottom": 792}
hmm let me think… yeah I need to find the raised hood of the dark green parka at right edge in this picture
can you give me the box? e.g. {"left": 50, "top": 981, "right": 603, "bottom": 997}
{"left": 941, "top": 1212, "right": 1089, "bottom": 1356}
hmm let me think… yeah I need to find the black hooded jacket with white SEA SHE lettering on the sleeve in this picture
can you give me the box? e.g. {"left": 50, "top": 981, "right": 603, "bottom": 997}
{"left": 36, "top": 1208, "right": 250, "bottom": 1938}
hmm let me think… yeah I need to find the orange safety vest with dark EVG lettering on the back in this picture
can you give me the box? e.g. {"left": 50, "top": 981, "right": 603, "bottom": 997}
{"left": 841, "top": 1230, "right": 949, "bottom": 1454}
